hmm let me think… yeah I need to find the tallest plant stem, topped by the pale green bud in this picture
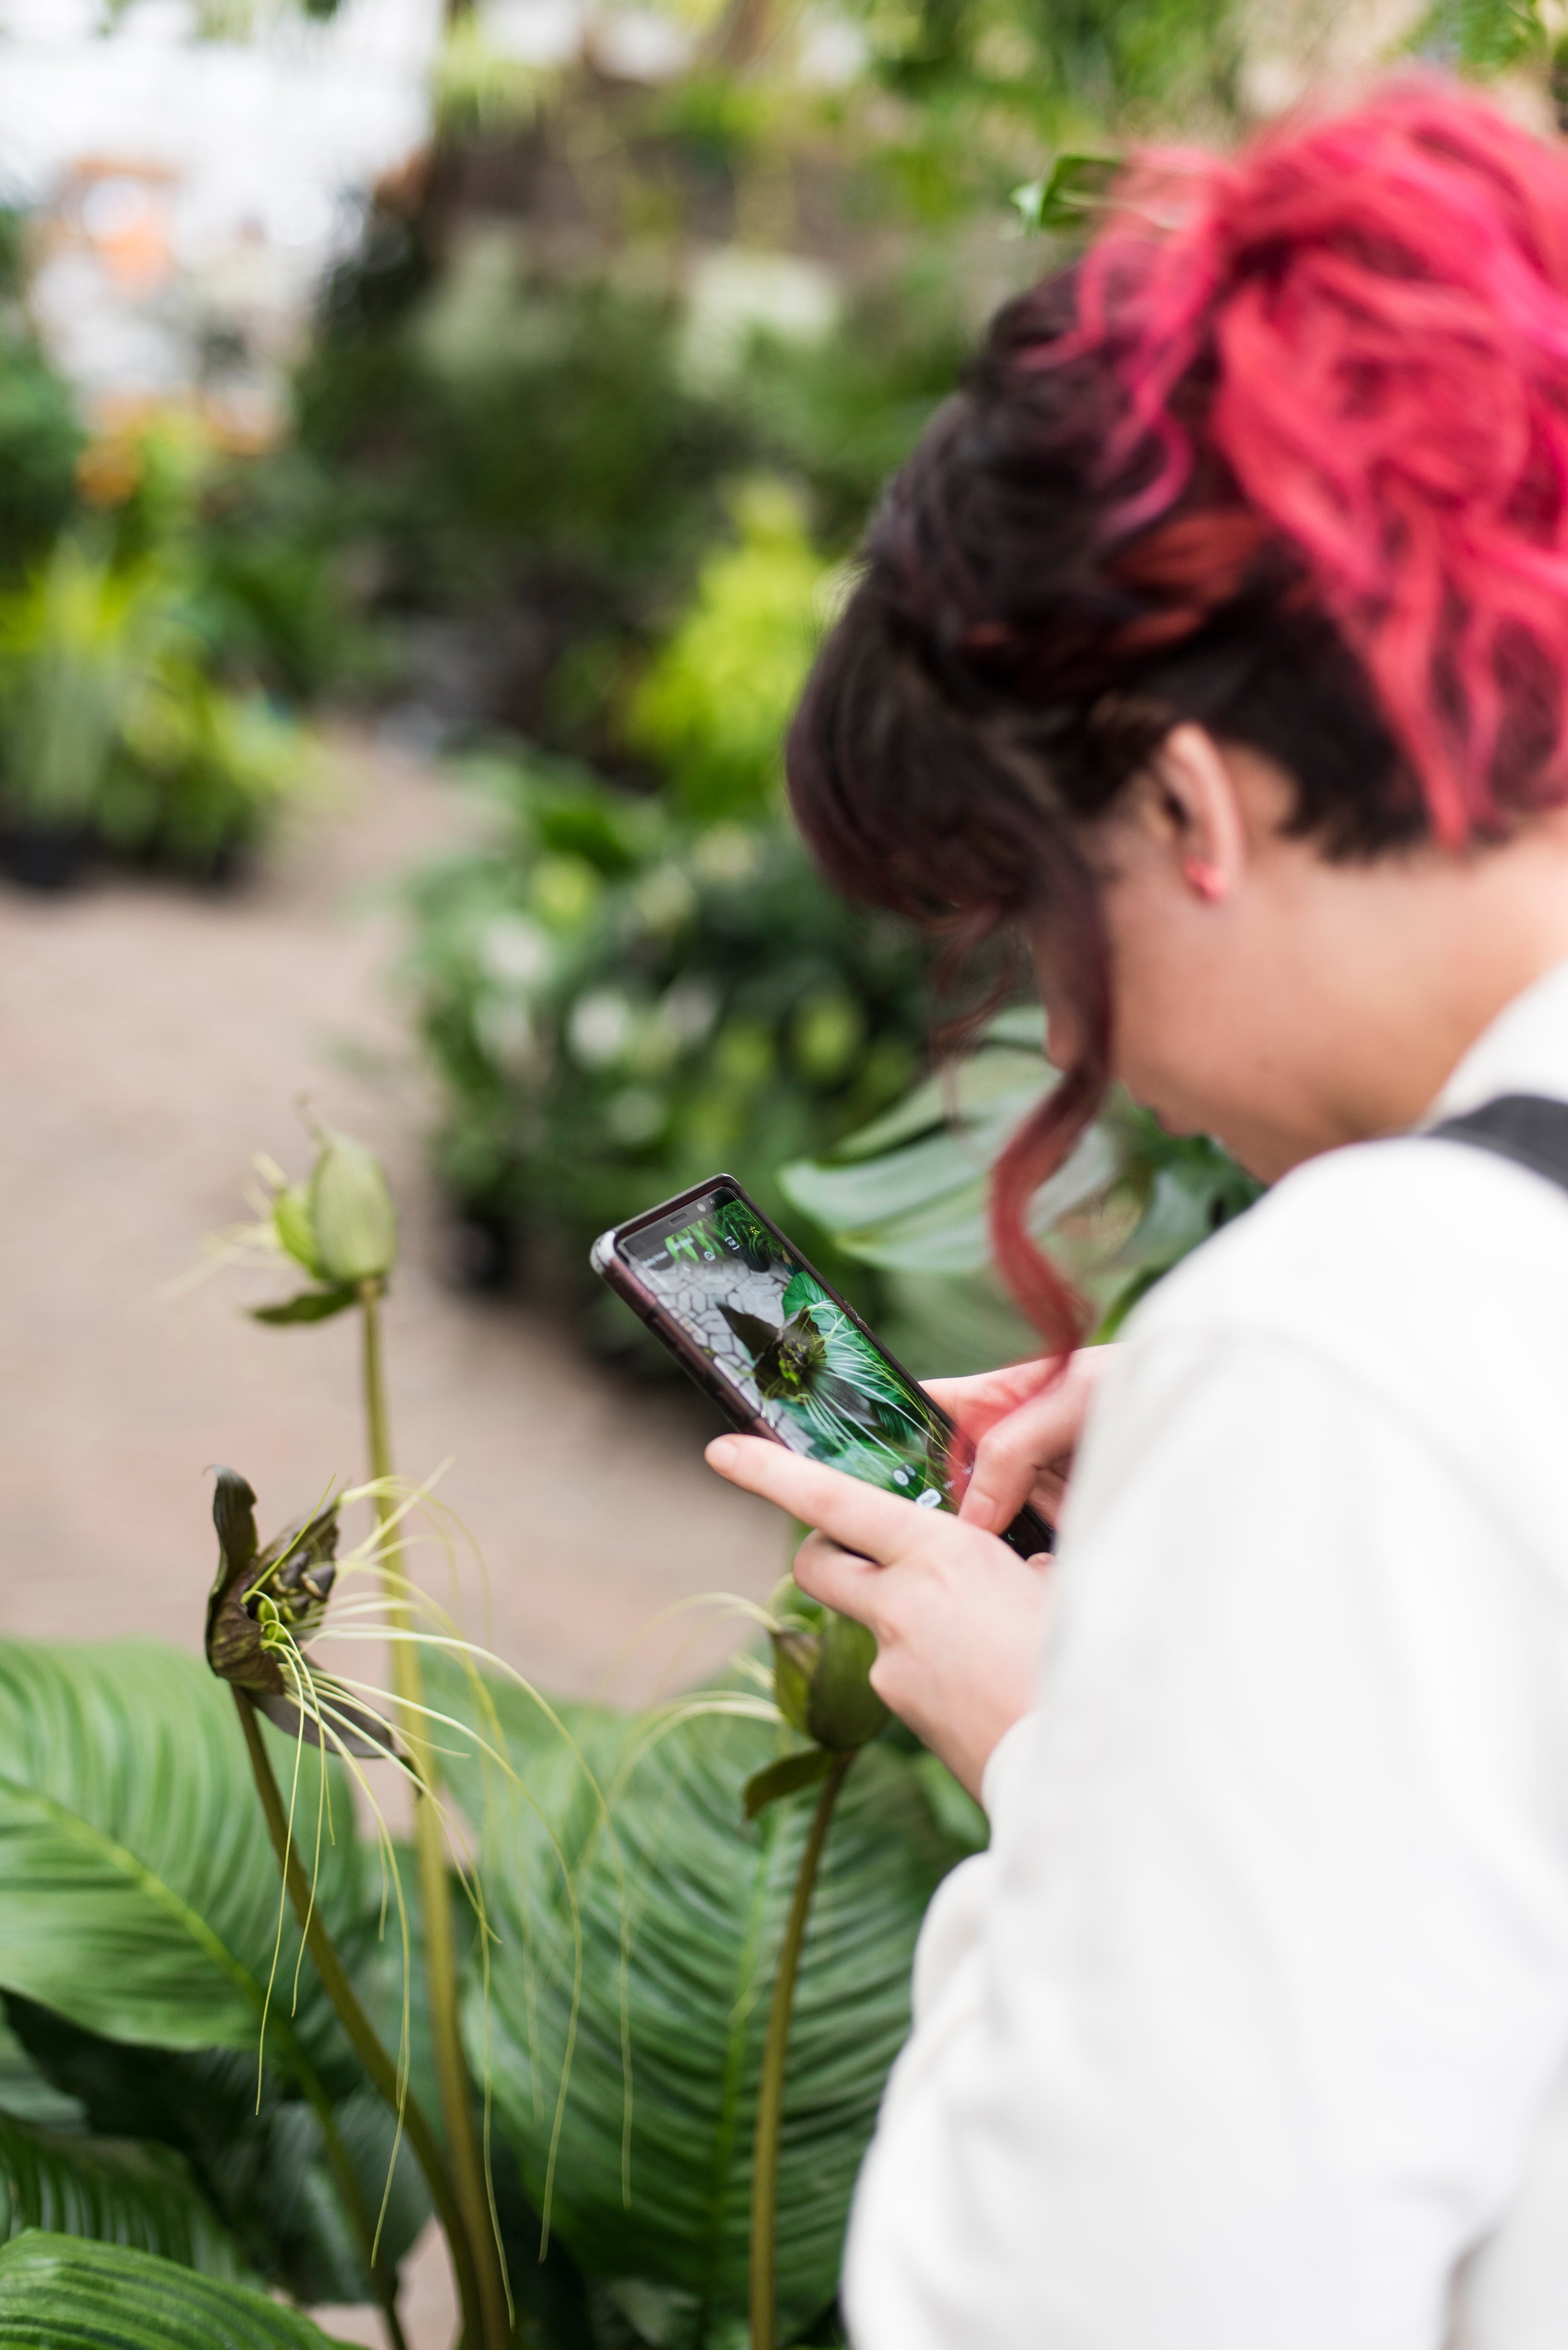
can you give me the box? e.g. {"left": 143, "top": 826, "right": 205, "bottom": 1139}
{"left": 360, "top": 1281, "right": 512, "bottom": 2350}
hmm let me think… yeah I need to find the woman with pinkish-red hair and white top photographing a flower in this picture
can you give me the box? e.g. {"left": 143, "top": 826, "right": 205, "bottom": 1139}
{"left": 710, "top": 80, "right": 1568, "bottom": 2350}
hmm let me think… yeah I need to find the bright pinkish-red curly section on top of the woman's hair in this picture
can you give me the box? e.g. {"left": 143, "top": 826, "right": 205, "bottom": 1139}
{"left": 1079, "top": 80, "right": 1568, "bottom": 846}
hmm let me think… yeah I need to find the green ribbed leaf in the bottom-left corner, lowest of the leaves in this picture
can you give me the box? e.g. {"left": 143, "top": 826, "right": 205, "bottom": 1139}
{"left": 0, "top": 2230, "right": 343, "bottom": 2350}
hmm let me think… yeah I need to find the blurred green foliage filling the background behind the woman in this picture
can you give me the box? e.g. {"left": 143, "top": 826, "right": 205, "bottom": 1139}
{"left": 0, "top": 0, "right": 1568, "bottom": 1368}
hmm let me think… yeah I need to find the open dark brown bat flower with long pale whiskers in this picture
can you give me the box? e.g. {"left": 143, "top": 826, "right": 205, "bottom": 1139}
{"left": 207, "top": 1469, "right": 395, "bottom": 1756}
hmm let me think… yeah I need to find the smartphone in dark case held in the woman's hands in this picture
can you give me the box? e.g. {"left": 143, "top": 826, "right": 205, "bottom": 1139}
{"left": 593, "top": 1175, "right": 1056, "bottom": 1558}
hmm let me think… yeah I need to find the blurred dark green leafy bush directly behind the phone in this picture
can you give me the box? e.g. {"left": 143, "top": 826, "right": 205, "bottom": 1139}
{"left": 411, "top": 761, "right": 922, "bottom": 1344}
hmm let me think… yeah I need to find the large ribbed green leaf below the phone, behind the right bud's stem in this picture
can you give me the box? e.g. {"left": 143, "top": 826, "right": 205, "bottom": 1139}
{"left": 446, "top": 1692, "right": 959, "bottom": 2350}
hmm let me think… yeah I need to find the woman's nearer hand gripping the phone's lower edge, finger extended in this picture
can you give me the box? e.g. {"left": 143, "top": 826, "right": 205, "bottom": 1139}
{"left": 708, "top": 1429, "right": 1051, "bottom": 1798}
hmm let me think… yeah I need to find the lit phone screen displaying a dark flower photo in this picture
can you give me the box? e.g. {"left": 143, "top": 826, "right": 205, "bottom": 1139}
{"left": 618, "top": 1187, "right": 957, "bottom": 1509}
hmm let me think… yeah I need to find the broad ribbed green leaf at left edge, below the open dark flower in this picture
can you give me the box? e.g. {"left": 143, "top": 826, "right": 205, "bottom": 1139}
{"left": 0, "top": 1640, "right": 364, "bottom": 2063}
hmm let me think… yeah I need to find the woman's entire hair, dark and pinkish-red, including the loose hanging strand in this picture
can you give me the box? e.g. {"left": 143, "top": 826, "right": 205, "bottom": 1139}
{"left": 790, "top": 78, "right": 1568, "bottom": 1344}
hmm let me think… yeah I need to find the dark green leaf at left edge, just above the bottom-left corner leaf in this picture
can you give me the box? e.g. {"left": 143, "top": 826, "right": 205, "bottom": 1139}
{"left": 0, "top": 2113, "right": 244, "bottom": 2277}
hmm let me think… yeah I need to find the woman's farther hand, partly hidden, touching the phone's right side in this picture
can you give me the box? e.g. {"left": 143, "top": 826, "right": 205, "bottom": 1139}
{"left": 926, "top": 1347, "right": 1117, "bottom": 1532}
